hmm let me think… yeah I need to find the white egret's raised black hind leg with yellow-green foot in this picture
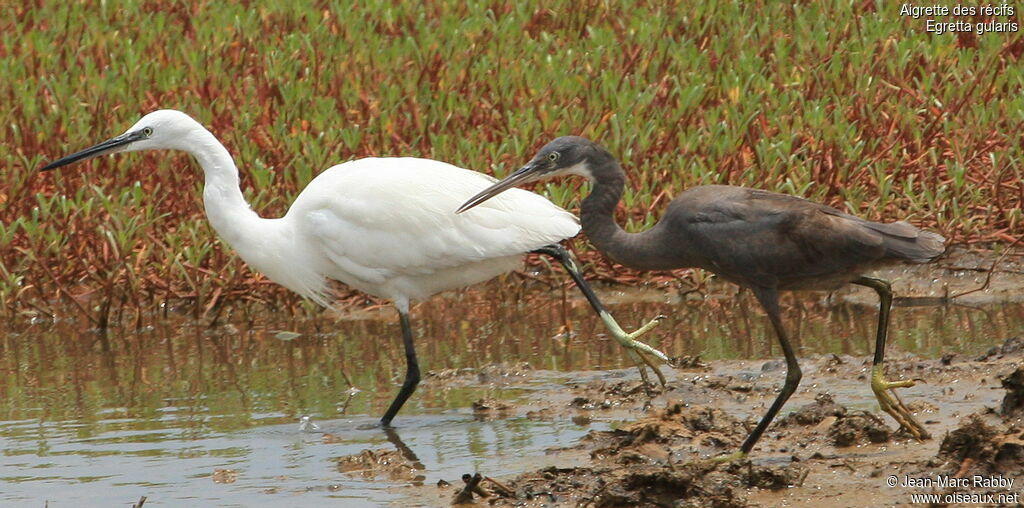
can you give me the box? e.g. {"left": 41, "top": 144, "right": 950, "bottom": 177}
{"left": 532, "top": 244, "right": 670, "bottom": 386}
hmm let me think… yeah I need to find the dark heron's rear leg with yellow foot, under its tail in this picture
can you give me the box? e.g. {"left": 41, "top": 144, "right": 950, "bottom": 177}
{"left": 853, "top": 277, "right": 931, "bottom": 439}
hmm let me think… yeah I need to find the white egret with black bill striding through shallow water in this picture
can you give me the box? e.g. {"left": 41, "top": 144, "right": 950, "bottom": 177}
{"left": 41, "top": 110, "right": 668, "bottom": 426}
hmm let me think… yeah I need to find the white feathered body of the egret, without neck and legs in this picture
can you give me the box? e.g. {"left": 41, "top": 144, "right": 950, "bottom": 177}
{"left": 284, "top": 158, "right": 580, "bottom": 301}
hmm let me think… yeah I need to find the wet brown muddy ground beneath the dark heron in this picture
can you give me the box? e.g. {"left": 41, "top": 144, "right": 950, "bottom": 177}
{"left": 339, "top": 337, "right": 1024, "bottom": 507}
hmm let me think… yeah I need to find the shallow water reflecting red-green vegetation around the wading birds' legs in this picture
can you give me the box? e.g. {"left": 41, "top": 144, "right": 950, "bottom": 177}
{"left": 0, "top": 286, "right": 1024, "bottom": 506}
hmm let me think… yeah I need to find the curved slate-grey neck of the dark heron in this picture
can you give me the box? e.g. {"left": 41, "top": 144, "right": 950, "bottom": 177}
{"left": 580, "top": 151, "right": 681, "bottom": 269}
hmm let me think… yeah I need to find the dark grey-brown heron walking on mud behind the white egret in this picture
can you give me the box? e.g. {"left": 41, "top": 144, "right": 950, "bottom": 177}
{"left": 458, "top": 136, "right": 945, "bottom": 459}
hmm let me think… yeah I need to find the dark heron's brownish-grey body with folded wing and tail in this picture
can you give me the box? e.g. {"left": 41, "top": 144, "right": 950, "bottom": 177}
{"left": 667, "top": 185, "right": 941, "bottom": 288}
